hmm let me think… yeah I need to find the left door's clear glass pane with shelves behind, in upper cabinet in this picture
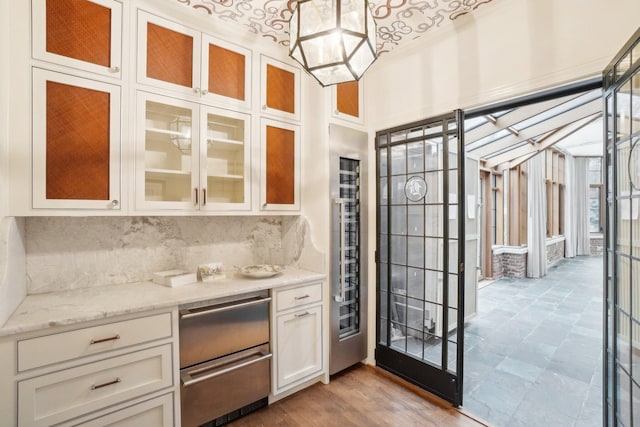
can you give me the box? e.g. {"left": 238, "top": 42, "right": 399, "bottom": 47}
{"left": 144, "top": 101, "right": 193, "bottom": 202}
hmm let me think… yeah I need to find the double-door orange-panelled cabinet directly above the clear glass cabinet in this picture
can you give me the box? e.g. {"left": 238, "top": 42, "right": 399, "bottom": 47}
{"left": 138, "top": 11, "right": 251, "bottom": 108}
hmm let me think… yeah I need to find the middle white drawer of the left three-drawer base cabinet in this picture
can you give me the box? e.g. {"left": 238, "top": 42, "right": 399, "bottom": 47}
{"left": 18, "top": 344, "right": 173, "bottom": 426}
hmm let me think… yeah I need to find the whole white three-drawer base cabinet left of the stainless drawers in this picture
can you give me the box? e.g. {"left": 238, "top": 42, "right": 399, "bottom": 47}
{"left": 3, "top": 312, "right": 178, "bottom": 426}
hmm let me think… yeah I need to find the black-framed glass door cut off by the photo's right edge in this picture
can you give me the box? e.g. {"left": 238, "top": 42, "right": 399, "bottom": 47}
{"left": 603, "top": 29, "right": 640, "bottom": 427}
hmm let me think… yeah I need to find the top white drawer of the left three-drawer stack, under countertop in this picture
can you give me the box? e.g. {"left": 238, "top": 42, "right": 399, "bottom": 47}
{"left": 18, "top": 313, "right": 171, "bottom": 371}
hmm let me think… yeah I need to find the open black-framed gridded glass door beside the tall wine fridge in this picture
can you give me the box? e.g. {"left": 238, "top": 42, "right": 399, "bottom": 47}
{"left": 376, "top": 110, "right": 465, "bottom": 406}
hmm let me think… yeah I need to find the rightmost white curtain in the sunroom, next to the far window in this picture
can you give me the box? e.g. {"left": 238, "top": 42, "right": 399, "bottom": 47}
{"left": 572, "top": 157, "right": 590, "bottom": 255}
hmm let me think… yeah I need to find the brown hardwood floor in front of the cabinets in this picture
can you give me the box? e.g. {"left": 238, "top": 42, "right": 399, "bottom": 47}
{"left": 228, "top": 365, "right": 485, "bottom": 427}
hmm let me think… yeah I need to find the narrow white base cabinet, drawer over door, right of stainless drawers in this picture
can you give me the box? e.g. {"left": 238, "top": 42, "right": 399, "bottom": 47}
{"left": 272, "top": 283, "right": 325, "bottom": 395}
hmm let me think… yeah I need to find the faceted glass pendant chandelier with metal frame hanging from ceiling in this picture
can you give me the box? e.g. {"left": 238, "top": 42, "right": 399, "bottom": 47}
{"left": 289, "top": 0, "right": 376, "bottom": 86}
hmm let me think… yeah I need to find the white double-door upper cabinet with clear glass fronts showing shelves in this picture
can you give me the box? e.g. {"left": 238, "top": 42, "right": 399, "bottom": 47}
{"left": 136, "top": 92, "right": 251, "bottom": 211}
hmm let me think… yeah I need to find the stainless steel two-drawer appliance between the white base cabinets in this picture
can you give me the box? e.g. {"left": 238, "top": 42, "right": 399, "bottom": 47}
{"left": 179, "top": 291, "right": 271, "bottom": 427}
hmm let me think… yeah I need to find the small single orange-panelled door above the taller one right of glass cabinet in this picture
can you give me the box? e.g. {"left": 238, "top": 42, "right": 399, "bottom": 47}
{"left": 261, "top": 55, "right": 300, "bottom": 120}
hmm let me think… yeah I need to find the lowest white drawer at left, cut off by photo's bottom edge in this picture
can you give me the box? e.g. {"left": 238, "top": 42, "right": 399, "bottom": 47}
{"left": 58, "top": 393, "right": 174, "bottom": 427}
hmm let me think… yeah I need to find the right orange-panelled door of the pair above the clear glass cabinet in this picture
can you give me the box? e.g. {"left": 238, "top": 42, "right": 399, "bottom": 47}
{"left": 202, "top": 34, "right": 251, "bottom": 107}
